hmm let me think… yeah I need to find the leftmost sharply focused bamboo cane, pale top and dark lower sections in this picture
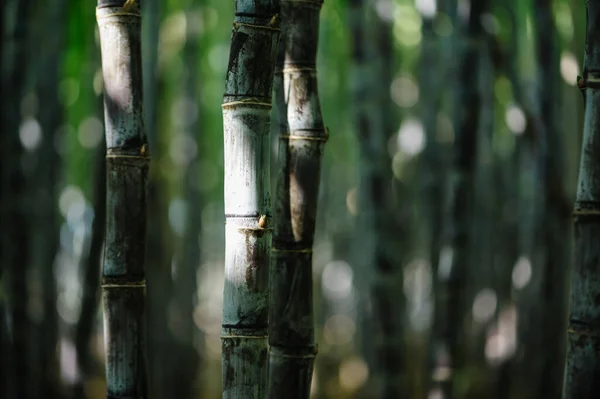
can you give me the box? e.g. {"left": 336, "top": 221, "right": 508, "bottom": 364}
{"left": 96, "top": 0, "right": 150, "bottom": 398}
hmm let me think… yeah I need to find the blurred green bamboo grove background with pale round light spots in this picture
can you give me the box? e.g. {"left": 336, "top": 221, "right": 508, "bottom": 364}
{"left": 0, "top": 0, "right": 585, "bottom": 399}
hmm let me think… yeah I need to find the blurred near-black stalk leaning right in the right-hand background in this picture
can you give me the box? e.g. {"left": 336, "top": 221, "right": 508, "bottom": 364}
{"left": 437, "top": 0, "right": 488, "bottom": 398}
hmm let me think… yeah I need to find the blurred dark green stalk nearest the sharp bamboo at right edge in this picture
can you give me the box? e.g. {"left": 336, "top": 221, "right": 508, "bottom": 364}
{"left": 503, "top": 0, "right": 546, "bottom": 397}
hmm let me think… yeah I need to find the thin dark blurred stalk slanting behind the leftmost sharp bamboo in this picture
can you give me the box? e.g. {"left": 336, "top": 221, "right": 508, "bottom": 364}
{"left": 75, "top": 140, "right": 106, "bottom": 398}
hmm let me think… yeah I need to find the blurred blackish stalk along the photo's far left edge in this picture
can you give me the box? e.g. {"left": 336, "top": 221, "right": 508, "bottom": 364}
{"left": 0, "top": 0, "right": 33, "bottom": 399}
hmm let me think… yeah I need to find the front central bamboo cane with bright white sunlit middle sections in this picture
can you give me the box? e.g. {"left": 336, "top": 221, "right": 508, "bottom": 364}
{"left": 222, "top": 0, "right": 279, "bottom": 398}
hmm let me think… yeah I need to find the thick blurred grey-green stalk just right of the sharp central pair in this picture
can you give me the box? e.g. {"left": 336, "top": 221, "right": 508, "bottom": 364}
{"left": 350, "top": 0, "right": 406, "bottom": 398}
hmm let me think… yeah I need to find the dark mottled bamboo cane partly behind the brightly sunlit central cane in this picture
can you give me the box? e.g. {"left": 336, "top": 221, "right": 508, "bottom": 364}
{"left": 268, "top": 0, "right": 327, "bottom": 399}
